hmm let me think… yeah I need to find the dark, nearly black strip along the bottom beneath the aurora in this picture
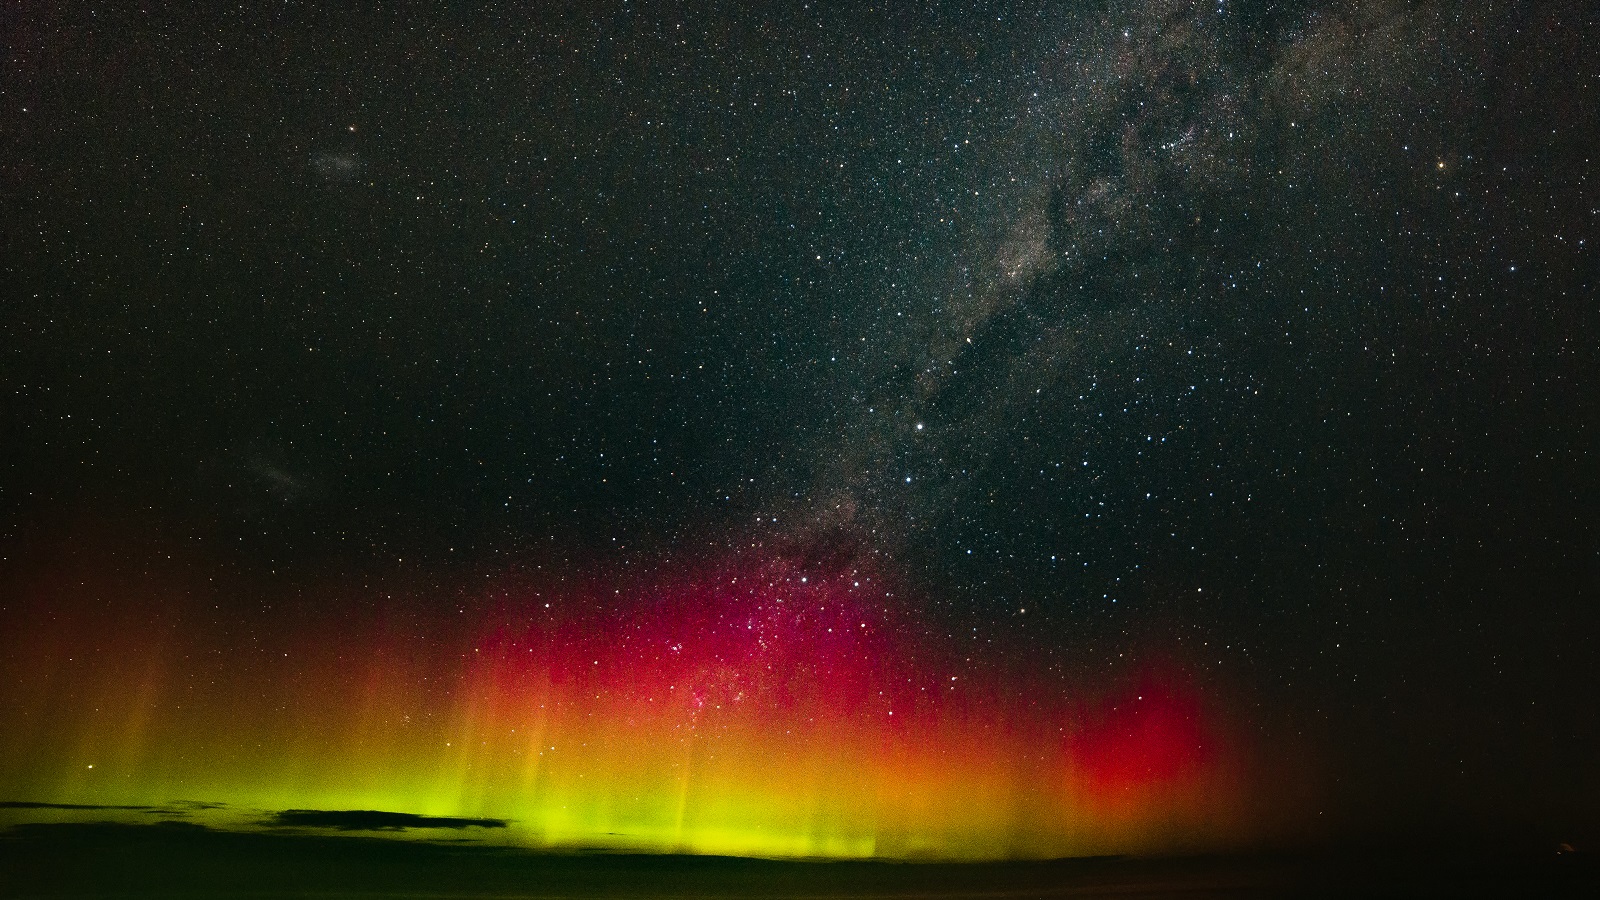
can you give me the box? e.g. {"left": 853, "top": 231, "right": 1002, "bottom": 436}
{"left": 0, "top": 825, "right": 1600, "bottom": 900}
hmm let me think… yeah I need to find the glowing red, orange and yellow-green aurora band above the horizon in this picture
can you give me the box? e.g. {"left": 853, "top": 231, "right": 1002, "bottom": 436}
{"left": 0, "top": 544, "right": 1245, "bottom": 858}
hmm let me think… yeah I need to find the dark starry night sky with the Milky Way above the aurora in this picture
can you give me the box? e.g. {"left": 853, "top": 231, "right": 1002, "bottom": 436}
{"left": 0, "top": 0, "right": 1600, "bottom": 833}
